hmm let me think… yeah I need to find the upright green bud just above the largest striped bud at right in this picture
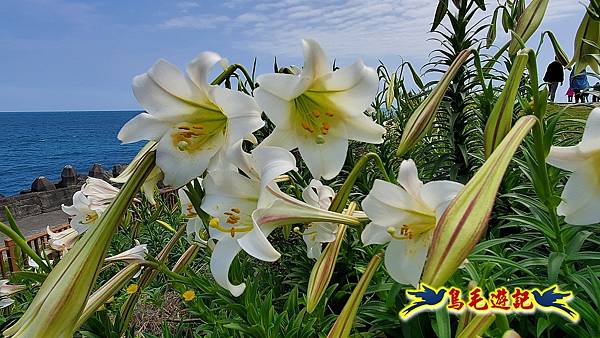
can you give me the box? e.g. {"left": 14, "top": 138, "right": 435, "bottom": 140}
{"left": 483, "top": 49, "right": 528, "bottom": 158}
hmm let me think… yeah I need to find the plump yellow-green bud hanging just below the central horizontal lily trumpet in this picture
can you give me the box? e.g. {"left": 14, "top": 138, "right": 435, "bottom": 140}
{"left": 306, "top": 203, "right": 356, "bottom": 313}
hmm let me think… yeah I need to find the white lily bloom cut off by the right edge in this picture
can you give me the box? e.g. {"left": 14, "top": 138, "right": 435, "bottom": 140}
{"left": 546, "top": 108, "right": 600, "bottom": 225}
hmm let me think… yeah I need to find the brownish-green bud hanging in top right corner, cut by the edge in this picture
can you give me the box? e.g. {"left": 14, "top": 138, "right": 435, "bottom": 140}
{"left": 567, "top": 12, "right": 600, "bottom": 74}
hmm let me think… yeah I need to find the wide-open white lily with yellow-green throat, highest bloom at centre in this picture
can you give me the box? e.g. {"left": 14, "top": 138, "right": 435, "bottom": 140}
{"left": 254, "top": 39, "right": 385, "bottom": 179}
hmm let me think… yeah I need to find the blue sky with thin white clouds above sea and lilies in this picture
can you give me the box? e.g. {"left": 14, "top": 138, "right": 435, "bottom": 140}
{"left": 0, "top": 0, "right": 585, "bottom": 112}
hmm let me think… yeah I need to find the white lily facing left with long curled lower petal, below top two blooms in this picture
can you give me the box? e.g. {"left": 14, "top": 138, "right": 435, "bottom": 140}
{"left": 202, "top": 142, "right": 296, "bottom": 297}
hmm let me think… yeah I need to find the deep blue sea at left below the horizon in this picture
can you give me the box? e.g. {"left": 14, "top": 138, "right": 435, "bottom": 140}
{"left": 0, "top": 111, "right": 144, "bottom": 196}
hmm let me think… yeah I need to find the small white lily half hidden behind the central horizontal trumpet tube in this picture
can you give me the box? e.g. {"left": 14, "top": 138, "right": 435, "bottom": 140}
{"left": 302, "top": 179, "right": 339, "bottom": 259}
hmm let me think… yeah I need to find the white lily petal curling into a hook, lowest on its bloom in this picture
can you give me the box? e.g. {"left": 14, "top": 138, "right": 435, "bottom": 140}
{"left": 210, "top": 237, "right": 246, "bottom": 297}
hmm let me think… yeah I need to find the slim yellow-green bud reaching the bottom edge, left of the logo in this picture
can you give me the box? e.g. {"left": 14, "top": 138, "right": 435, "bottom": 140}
{"left": 327, "top": 253, "right": 383, "bottom": 338}
